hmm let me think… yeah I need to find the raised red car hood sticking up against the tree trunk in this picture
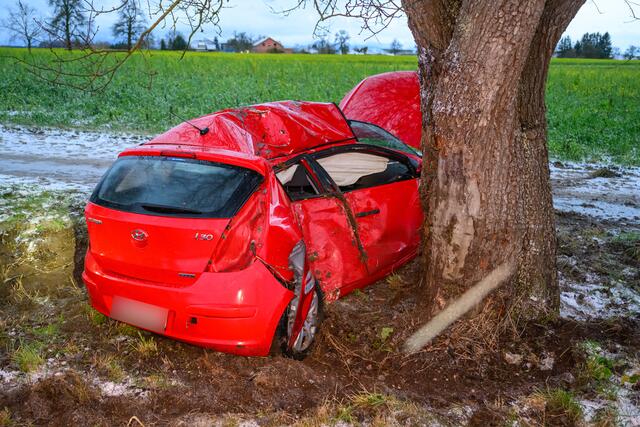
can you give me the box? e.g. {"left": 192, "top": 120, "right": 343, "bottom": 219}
{"left": 340, "top": 71, "right": 422, "bottom": 149}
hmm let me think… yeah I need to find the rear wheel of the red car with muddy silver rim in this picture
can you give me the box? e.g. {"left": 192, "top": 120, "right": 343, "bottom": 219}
{"left": 272, "top": 286, "right": 323, "bottom": 360}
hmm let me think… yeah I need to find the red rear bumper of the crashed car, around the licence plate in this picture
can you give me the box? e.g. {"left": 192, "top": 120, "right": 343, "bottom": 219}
{"left": 82, "top": 253, "right": 293, "bottom": 356}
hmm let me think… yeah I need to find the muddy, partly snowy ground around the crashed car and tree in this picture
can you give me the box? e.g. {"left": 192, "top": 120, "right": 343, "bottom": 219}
{"left": 0, "top": 126, "right": 640, "bottom": 426}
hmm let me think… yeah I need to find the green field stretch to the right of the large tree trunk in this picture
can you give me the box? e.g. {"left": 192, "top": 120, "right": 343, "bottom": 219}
{"left": 547, "top": 59, "right": 640, "bottom": 165}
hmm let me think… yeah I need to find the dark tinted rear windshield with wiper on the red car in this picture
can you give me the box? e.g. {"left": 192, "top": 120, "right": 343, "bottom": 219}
{"left": 91, "top": 156, "right": 262, "bottom": 218}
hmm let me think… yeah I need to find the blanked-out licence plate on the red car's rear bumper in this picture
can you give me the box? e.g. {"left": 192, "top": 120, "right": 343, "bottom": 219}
{"left": 111, "top": 296, "right": 169, "bottom": 333}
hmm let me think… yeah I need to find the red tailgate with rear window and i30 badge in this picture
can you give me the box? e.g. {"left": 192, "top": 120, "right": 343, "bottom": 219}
{"left": 85, "top": 156, "right": 262, "bottom": 286}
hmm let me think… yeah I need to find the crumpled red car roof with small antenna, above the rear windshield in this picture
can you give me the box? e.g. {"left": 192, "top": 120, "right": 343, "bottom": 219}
{"left": 145, "top": 101, "right": 355, "bottom": 160}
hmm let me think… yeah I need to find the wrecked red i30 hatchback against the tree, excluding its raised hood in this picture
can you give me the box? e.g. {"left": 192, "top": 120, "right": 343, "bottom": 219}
{"left": 83, "top": 72, "right": 422, "bottom": 357}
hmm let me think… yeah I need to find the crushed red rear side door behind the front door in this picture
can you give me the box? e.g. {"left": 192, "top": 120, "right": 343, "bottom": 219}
{"left": 276, "top": 156, "right": 367, "bottom": 300}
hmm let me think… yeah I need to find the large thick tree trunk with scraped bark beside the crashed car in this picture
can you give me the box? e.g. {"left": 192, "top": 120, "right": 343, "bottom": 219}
{"left": 404, "top": 0, "right": 584, "bottom": 334}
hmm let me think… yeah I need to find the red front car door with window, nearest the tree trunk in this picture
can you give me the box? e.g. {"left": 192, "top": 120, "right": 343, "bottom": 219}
{"left": 314, "top": 144, "right": 422, "bottom": 277}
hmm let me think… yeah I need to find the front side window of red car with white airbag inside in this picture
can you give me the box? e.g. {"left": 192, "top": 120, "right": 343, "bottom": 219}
{"left": 316, "top": 151, "right": 416, "bottom": 192}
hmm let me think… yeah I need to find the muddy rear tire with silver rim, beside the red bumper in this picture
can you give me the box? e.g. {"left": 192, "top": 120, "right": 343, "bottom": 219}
{"left": 271, "top": 285, "right": 324, "bottom": 360}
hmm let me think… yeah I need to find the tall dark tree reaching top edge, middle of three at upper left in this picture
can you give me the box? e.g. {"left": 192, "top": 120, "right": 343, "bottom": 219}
{"left": 45, "top": 0, "right": 91, "bottom": 50}
